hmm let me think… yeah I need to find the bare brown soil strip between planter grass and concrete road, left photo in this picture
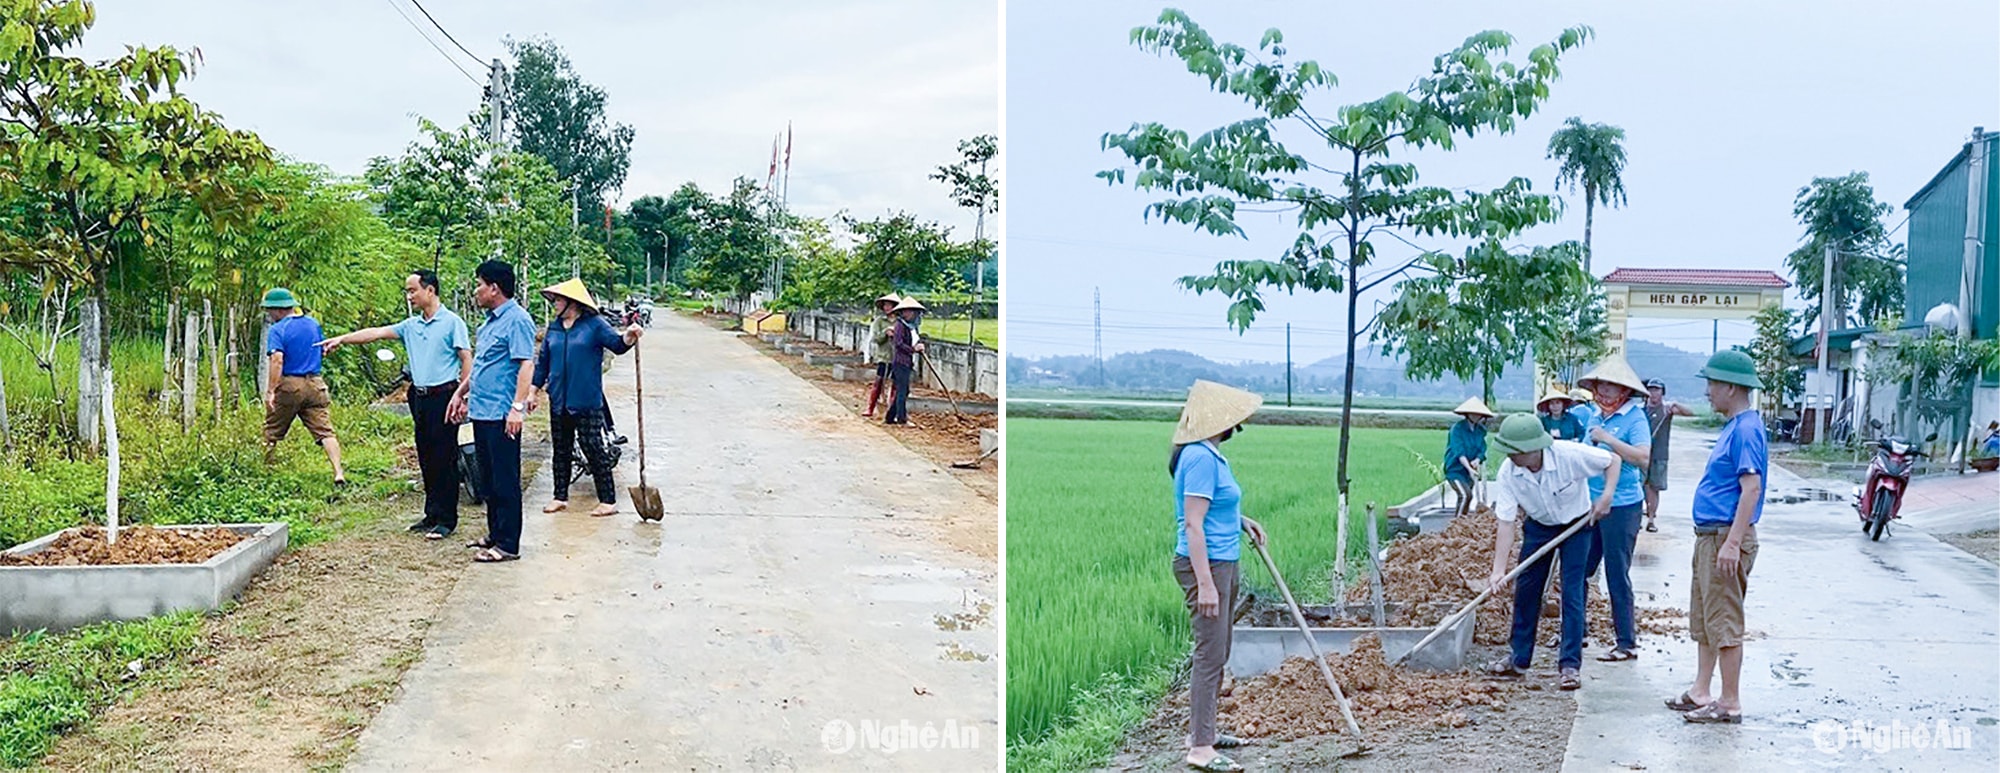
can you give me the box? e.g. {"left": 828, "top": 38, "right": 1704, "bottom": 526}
{"left": 44, "top": 497, "right": 468, "bottom": 771}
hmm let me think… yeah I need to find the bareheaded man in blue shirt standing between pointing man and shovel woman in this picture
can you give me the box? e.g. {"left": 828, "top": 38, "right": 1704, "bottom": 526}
{"left": 450, "top": 260, "right": 534, "bottom": 563}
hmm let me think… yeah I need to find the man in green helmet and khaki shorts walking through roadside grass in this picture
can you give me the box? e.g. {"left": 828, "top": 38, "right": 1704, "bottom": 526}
{"left": 264, "top": 286, "right": 348, "bottom": 487}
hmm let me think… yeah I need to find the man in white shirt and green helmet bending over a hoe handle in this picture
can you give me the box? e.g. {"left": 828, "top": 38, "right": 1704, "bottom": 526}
{"left": 1488, "top": 413, "right": 1622, "bottom": 689}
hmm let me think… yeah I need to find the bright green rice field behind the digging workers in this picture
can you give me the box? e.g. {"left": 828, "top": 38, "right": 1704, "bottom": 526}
{"left": 1006, "top": 417, "right": 1444, "bottom": 769}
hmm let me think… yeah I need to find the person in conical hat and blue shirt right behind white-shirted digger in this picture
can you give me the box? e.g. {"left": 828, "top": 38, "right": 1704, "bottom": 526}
{"left": 1574, "top": 354, "right": 1652, "bottom": 663}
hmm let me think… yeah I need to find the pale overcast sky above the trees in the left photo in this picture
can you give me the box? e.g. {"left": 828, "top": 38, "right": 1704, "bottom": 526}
{"left": 84, "top": 0, "right": 1000, "bottom": 238}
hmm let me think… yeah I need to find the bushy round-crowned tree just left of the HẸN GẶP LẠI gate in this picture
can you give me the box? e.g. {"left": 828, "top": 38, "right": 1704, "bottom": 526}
{"left": 1374, "top": 238, "right": 1596, "bottom": 405}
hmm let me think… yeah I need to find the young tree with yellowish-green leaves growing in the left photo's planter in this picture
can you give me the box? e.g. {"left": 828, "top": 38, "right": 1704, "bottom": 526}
{"left": 0, "top": 0, "right": 272, "bottom": 453}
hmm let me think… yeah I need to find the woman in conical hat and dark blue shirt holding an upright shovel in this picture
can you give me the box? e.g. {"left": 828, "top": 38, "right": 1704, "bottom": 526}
{"left": 528, "top": 278, "right": 640, "bottom": 517}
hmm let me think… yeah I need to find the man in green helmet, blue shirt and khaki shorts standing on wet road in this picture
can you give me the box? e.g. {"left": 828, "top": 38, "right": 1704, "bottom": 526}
{"left": 1666, "top": 350, "right": 1770, "bottom": 725}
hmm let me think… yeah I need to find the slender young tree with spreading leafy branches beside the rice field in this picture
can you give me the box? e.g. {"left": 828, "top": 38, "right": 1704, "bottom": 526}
{"left": 1098, "top": 8, "right": 1592, "bottom": 553}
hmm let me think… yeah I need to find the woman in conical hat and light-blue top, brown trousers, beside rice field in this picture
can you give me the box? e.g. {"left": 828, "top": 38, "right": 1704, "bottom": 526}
{"left": 1166, "top": 380, "right": 1264, "bottom": 771}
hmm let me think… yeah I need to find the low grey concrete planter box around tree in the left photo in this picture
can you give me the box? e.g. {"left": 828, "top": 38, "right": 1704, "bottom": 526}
{"left": 0, "top": 523, "right": 290, "bottom": 635}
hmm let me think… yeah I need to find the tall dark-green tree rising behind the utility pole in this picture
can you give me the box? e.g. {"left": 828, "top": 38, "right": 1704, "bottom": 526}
{"left": 506, "top": 38, "right": 632, "bottom": 216}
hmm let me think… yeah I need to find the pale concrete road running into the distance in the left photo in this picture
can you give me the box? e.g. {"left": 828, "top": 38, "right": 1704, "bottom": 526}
{"left": 352, "top": 314, "right": 1000, "bottom": 771}
